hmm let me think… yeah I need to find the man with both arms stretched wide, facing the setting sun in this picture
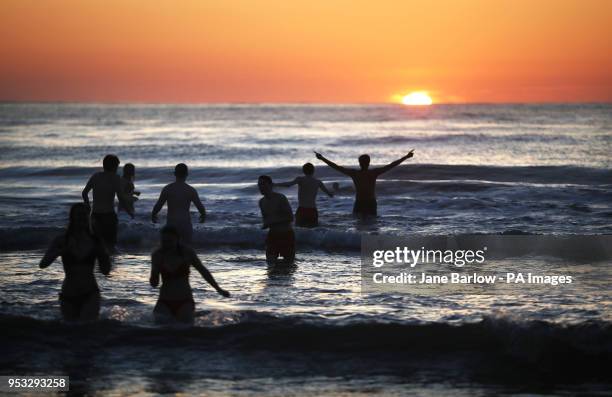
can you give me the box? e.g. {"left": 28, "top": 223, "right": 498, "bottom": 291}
{"left": 315, "top": 150, "right": 414, "bottom": 217}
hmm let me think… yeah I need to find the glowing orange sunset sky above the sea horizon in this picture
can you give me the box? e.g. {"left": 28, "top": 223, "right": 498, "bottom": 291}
{"left": 0, "top": 0, "right": 612, "bottom": 103}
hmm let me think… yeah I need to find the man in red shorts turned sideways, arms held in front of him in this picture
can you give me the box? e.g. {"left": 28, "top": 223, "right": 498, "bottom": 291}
{"left": 257, "top": 175, "right": 295, "bottom": 264}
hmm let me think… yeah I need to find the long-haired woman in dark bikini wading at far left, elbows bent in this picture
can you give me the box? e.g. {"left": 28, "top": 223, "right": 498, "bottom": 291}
{"left": 39, "top": 203, "right": 111, "bottom": 320}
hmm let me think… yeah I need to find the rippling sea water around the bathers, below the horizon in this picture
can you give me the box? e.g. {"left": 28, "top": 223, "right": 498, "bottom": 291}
{"left": 0, "top": 104, "right": 612, "bottom": 395}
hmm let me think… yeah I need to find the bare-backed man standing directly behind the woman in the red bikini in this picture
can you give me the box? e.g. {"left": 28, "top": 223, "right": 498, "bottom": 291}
{"left": 151, "top": 163, "right": 206, "bottom": 245}
